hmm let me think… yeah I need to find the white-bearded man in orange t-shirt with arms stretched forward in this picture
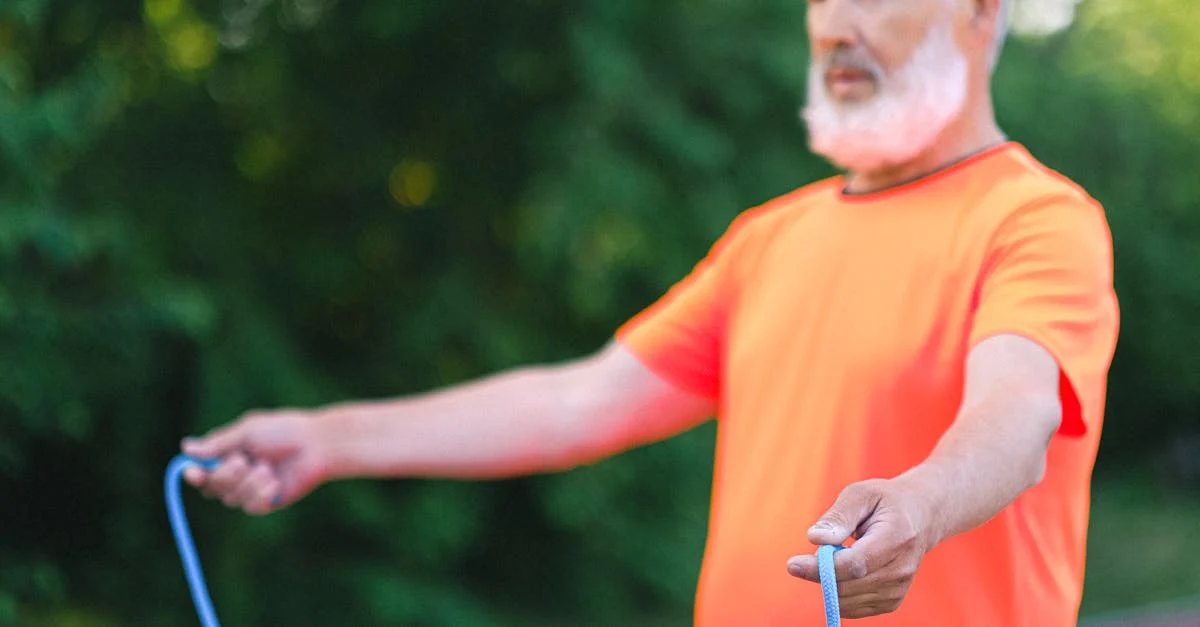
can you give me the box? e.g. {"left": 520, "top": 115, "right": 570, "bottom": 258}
{"left": 184, "top": 0, "right": 1117, "bottom": 627}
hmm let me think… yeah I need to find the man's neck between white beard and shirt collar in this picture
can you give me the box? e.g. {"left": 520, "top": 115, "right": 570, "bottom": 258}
{"left": 845, "top": 123, "right": 1006, "bottom": 193}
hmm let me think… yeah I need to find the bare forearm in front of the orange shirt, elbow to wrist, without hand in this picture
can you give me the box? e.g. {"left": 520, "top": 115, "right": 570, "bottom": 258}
{"left": 899, "top": 399, "right": 1061, "bottom": 547}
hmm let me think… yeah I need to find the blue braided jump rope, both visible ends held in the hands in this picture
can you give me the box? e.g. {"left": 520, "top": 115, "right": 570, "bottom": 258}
{"left": 164, "top": 455, "right": 841, "bottom": 627}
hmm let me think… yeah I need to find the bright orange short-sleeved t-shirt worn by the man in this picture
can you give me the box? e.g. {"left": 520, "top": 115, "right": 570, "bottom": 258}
{"left": 617, "top": 143, "right": 1117, "bottom": 627}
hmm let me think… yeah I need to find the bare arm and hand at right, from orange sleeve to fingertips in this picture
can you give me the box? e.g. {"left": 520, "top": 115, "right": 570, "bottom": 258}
{"left": 787, "top": 335, "right": 1062, "bottom": 619}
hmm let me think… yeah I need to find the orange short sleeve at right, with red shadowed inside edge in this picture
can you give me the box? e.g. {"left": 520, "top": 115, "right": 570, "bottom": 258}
{"left": 970, "top": 197, "right": 1118, "bottom": 436}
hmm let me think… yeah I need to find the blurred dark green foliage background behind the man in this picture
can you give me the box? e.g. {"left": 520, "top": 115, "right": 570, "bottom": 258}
{"left": 0, "top": 0, "right": 1200, "bottom": 626}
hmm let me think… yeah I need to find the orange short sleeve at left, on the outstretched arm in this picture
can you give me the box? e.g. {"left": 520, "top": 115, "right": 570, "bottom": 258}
{"left": 616, "top": 210, "right": 755, "bottom": 400}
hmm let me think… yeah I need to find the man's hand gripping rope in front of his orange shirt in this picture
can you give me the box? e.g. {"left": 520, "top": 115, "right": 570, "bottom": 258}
{"left": 787, "top": 478, "right": 937, "bottom": 619}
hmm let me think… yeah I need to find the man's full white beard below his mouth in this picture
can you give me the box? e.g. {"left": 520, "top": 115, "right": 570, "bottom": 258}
{"left": 803, "top": 23, "right": 967, "bottom": 172}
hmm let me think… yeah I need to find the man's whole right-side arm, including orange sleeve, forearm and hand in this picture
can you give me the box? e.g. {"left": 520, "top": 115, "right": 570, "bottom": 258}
{"left": 787, "top": 197, "right": 1118, "bottom": 617}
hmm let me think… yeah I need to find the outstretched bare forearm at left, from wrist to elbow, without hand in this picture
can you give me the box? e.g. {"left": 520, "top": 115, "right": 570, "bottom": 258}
{"left": 314, "top": 366, "right": 590, "bottom": 478}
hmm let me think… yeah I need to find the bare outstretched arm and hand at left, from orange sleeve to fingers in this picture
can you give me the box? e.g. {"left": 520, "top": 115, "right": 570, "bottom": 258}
{"left": 177, "top": 342, "right": 714, "bottom": 514}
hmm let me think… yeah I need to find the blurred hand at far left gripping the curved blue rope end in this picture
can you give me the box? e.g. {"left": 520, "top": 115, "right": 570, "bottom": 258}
{"left": 182, "top": 410, "right": 328, "bottom": 515}
